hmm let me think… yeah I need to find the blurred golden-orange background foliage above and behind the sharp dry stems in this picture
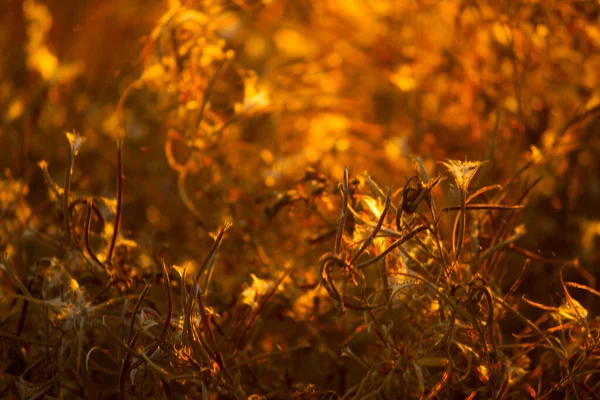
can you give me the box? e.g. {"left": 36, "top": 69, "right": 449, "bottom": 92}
{"left": 0, "top": 0, "right": 600, "bottom": 394}
